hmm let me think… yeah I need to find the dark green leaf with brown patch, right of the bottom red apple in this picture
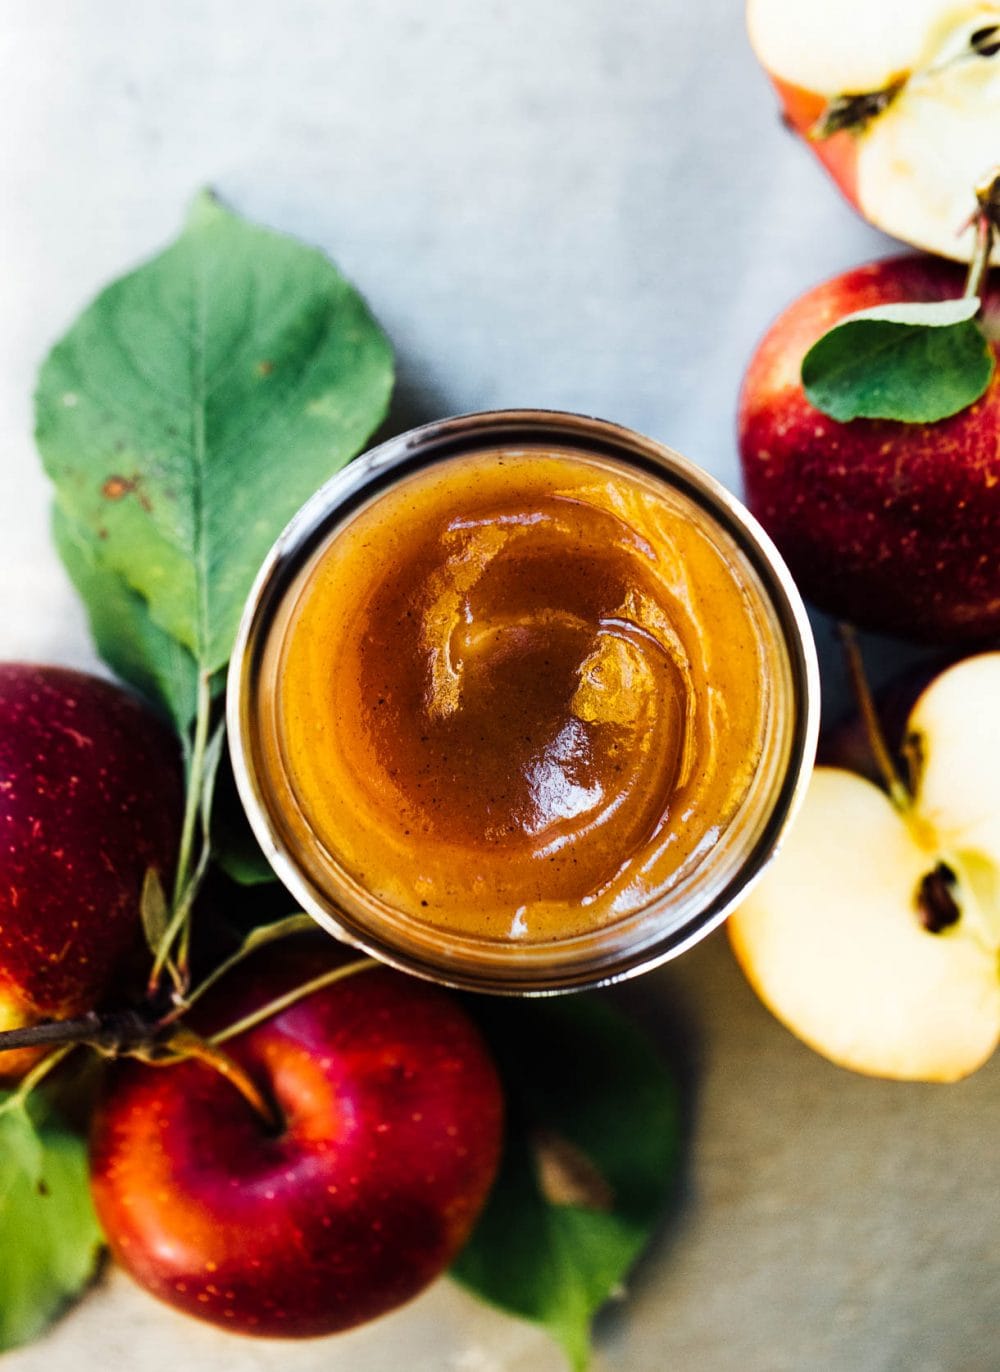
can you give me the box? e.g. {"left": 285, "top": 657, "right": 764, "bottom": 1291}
{"left": 453, "top": 996, "right": 679, "bottom": 1369}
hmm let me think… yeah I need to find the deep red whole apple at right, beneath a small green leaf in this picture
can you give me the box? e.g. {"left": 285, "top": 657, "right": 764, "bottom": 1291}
{"left": 739, "top": 254, "right": 1000, "bottom": 643}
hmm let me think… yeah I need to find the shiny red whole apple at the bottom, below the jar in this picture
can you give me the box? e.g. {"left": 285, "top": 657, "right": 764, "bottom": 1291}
{"left": 92, "top": 940, "right": 502, "bottom": 1338}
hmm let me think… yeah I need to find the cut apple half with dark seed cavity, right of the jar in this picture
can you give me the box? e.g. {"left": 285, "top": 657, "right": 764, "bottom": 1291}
{"left": 728, "top": 653, "right": 1000, "bottom": 1081}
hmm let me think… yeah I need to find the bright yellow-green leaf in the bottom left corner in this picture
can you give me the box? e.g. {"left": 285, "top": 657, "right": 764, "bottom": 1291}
{"left": 0, "top": 1106, "right": 102, "bottom": 1351}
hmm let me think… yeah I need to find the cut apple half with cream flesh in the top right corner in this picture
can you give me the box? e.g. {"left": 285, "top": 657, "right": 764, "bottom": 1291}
{"left": 746, "top": 0, "right": 1000, "bottom": 262}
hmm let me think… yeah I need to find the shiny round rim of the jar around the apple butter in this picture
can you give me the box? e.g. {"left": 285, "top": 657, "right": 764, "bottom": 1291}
{"left": 226, "top": 409, "right": 819, "bottom": 995}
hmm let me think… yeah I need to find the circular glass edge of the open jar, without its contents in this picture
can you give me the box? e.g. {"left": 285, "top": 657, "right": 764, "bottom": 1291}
{"left": 228, "top": 410, "right": 819, "bottom": 995}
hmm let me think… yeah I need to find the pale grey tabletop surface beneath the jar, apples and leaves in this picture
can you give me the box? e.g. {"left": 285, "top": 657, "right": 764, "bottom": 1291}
{"left": 0, "top": 0, "right": 1000, "bottom": 1372}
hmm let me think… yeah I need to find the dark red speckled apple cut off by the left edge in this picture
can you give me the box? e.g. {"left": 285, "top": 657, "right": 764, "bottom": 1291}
{"left": 0, "top": 663, "right": 184, "bottom": 1078}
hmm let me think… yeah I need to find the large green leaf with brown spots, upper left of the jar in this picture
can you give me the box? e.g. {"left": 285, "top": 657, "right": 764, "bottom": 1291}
{"left": 36, "top": 193, "right": 392, "bottom": 672}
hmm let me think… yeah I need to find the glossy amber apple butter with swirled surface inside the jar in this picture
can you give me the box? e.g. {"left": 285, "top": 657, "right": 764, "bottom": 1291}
{"left": 277, "top": 451, "right": 767, "bottom": 941}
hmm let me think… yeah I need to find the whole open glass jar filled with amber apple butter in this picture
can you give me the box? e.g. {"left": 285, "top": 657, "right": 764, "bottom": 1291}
{"left": 229, "top": 410, "right": 819, "bottom": 993}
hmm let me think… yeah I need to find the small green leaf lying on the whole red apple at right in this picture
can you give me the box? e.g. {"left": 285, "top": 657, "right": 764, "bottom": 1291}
{"left": 802, "top": 296, "right": 996, "bottom": 424}
